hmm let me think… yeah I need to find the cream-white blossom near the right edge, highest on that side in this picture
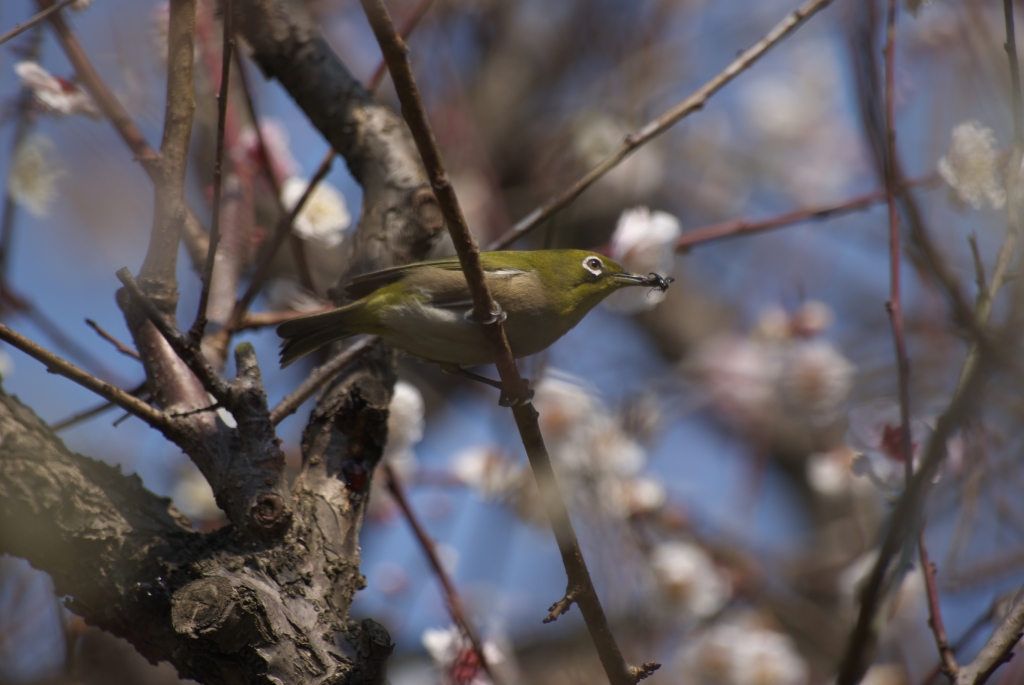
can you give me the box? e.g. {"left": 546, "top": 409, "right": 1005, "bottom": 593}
{"left": 939, "top": 121, "right": 1007, "bottom": 209}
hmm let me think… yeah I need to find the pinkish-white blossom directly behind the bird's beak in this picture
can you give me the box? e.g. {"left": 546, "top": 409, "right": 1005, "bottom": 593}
{"left": 604, "top": 207, "right": 681, "bottom": 313}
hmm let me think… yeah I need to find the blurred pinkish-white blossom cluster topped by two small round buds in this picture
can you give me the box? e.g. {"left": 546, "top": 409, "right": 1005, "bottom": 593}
{"left": 686, "top": 302, "right": 856, "bottom": 430}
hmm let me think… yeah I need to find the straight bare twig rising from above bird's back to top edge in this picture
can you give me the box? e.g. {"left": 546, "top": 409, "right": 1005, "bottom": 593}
{"left": 487, "top": 0, "right": 831, "bottom": 250}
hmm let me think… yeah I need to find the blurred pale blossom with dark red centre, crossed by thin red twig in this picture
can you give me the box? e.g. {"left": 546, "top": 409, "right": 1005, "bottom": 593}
{"left": 846, "top": 397, "right": 931, "bottom": 494}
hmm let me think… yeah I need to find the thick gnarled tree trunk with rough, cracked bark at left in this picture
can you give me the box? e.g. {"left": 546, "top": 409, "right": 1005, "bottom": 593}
{"left": 0, "top": 0, "right": 442, "bottom": 685}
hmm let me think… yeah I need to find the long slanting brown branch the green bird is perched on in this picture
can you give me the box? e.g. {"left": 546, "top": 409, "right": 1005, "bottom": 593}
{"left": 360, "top": 0, "right": 651, "bottom": 685}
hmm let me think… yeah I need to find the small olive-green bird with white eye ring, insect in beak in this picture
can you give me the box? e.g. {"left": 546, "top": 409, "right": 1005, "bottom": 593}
{"left": 278, "top": 250, "right": 673, "bottom": 370}
